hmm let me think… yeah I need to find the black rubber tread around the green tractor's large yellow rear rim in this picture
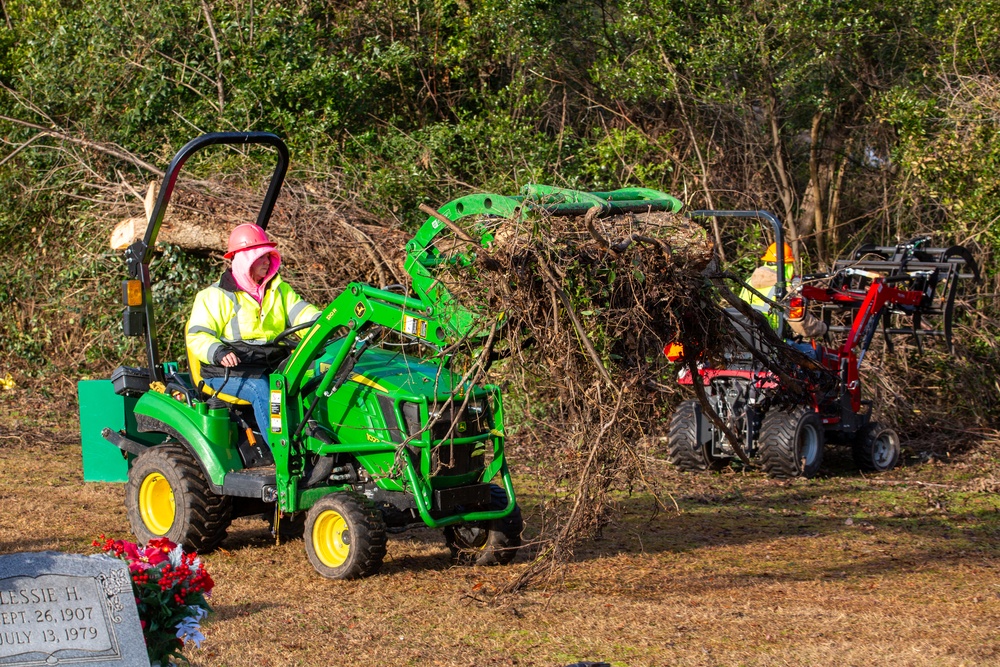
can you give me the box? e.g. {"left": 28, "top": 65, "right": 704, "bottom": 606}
{"left": 125, "top": 443, "right": 232, "bottom": 553}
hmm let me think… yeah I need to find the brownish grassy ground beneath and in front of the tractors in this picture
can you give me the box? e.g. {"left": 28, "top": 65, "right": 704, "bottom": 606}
{"left": 0, "top": 394, "right": 1000, "bottom": 667}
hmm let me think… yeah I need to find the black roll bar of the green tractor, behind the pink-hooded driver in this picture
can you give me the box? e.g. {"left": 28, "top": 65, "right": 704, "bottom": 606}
{"left": 125, "top": 132, "right": 288, "bottom": 382}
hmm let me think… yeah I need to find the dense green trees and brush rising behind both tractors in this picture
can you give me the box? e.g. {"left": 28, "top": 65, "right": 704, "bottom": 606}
{"left": 0, "top": 0, "right": 1000, "bottom": 428}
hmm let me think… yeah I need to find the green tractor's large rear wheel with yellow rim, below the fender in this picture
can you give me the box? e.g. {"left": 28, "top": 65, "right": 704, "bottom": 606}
{"left": 125, "top": 442, "right": 232, "bottom": 553}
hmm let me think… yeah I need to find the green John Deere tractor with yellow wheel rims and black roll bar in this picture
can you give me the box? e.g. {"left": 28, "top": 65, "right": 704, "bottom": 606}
{"left": 79, "top": 132, "right": 523, "bottom": 579}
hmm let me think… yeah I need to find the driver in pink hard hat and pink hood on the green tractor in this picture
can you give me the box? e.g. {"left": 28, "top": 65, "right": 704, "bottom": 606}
{"left": 185, "top": 224, "right": 320, "bottom": 440}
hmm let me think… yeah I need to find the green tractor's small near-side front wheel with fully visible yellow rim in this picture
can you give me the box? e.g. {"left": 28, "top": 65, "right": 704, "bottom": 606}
{"left": 304, "top": 492, "right": 386, "bottom": 579}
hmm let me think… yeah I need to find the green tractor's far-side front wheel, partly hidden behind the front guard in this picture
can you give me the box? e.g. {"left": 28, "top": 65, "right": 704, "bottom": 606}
{"left": 444, "top": 484, "right": 524, "bottom": 565}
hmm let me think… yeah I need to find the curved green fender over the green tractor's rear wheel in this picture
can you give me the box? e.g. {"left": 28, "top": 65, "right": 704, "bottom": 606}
{"left": 133, "top": 391, "right": 243, "bottom": 494}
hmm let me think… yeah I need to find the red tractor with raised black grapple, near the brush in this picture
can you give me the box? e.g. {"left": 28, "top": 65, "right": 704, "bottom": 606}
{"left": 664, "top": 211, "right": 979, "bottom": 478}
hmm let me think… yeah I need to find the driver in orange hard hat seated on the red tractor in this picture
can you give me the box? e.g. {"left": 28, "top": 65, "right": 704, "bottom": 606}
{"left": 740, "top": 243, "right": 827, "bottom": 359}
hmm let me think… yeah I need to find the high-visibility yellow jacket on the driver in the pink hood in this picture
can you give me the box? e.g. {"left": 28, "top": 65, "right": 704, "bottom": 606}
{"left": 185, "top": 270, "right": 319, "bottom": 365}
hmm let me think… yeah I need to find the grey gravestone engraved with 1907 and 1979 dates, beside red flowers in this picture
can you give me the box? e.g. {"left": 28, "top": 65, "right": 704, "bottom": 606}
{"left": 0, "top": 551, "right": 149, "bottom": 667}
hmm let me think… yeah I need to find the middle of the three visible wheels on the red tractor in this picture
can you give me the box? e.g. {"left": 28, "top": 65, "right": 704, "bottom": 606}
{"left": 758, "top": 405, "right": 823, "bottom": 479}
